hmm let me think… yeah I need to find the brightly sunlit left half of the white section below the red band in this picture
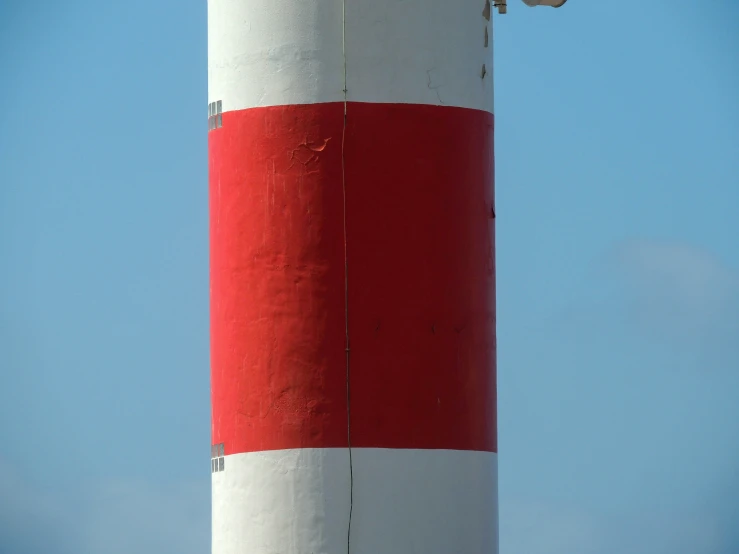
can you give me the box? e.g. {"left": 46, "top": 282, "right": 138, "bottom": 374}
{"left": 212, "top": 449, "right": 350, "bottom": 554}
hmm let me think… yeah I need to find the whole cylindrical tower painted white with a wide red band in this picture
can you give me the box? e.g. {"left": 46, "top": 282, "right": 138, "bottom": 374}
{"left": 208, "top": 0, "right": 498, "bottom": 554}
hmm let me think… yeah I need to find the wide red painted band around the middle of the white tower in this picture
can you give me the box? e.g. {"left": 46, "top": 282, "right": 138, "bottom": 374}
{"left": 209, "top": 103, "right": 497, "bottom": 454}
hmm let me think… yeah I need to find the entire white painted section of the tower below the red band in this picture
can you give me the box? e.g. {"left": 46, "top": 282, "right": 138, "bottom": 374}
{"left": 212, "top": 448, "right": 498, "bottom": 554}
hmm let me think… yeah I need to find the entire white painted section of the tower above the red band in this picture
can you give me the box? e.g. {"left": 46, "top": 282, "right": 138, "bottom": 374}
{"left": 208, "top": 0, "right": 493, "bottom": 112}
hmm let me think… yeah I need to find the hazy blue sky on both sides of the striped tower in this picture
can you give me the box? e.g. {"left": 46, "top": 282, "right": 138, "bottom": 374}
{"left": 0, "top": 0, "right": 739, "bottom": 554}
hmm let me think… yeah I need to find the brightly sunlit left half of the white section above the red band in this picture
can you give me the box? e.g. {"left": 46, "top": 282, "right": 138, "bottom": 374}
{"left": 208, "top": 0, "right": 344, "bottom": 112}
